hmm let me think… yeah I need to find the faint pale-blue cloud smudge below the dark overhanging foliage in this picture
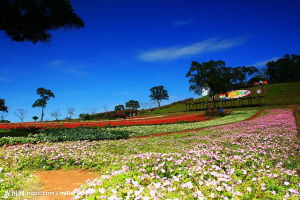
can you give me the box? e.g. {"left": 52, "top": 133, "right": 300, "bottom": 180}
{"left": 48, "top": 60, "right": 89, "bottom": 77}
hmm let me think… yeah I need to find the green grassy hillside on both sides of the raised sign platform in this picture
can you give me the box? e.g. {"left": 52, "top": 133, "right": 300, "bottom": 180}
{"left": 144, "top": 82, "right": 300, "bottom": 115}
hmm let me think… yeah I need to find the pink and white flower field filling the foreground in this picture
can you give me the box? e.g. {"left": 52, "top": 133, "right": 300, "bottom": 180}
{"left": 0, "top": 109, "right": 300, "bottom": 200}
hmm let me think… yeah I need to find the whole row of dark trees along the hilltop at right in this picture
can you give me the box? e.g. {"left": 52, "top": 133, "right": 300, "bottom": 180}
{"left": 186, "top": 54, "right": 300, "bottom": 104}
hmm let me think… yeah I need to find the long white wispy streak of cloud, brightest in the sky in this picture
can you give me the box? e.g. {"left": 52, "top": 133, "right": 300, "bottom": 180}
{"left": 138, "top": 37, "right": 247, "bottom": 61}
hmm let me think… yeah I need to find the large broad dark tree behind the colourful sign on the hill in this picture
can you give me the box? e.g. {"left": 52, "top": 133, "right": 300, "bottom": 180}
{"left": 186, "top": 60, "right": 257, "bottom": 108}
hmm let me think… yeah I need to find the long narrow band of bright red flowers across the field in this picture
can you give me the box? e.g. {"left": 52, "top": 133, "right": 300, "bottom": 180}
{"left": 0, "top": 114, "right": 209, "bottom": 130}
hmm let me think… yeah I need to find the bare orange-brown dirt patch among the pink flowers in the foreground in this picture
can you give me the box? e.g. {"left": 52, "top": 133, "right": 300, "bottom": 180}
{"left": 35, "top": 170, "right": 98, "bottom": 200}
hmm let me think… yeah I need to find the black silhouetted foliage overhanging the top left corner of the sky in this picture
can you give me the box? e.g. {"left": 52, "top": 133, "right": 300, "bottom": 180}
{"left": 0, "top": 0, "right": 84, "bottom": 43}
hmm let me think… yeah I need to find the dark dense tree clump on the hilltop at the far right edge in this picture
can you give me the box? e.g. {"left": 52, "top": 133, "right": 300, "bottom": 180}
{"left": 266, "top": 54, "right": 300, "bottom": 83}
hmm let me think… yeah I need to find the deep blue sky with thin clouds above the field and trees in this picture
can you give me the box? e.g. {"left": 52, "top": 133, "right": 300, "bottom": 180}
{"left": 0, "top": 0, "right": 300, "bottom": 122}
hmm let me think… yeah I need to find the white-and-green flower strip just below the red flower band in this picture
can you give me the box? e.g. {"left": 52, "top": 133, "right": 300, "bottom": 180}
{"left": 0, "top": 110, "right": 257, "bottom": 146}
